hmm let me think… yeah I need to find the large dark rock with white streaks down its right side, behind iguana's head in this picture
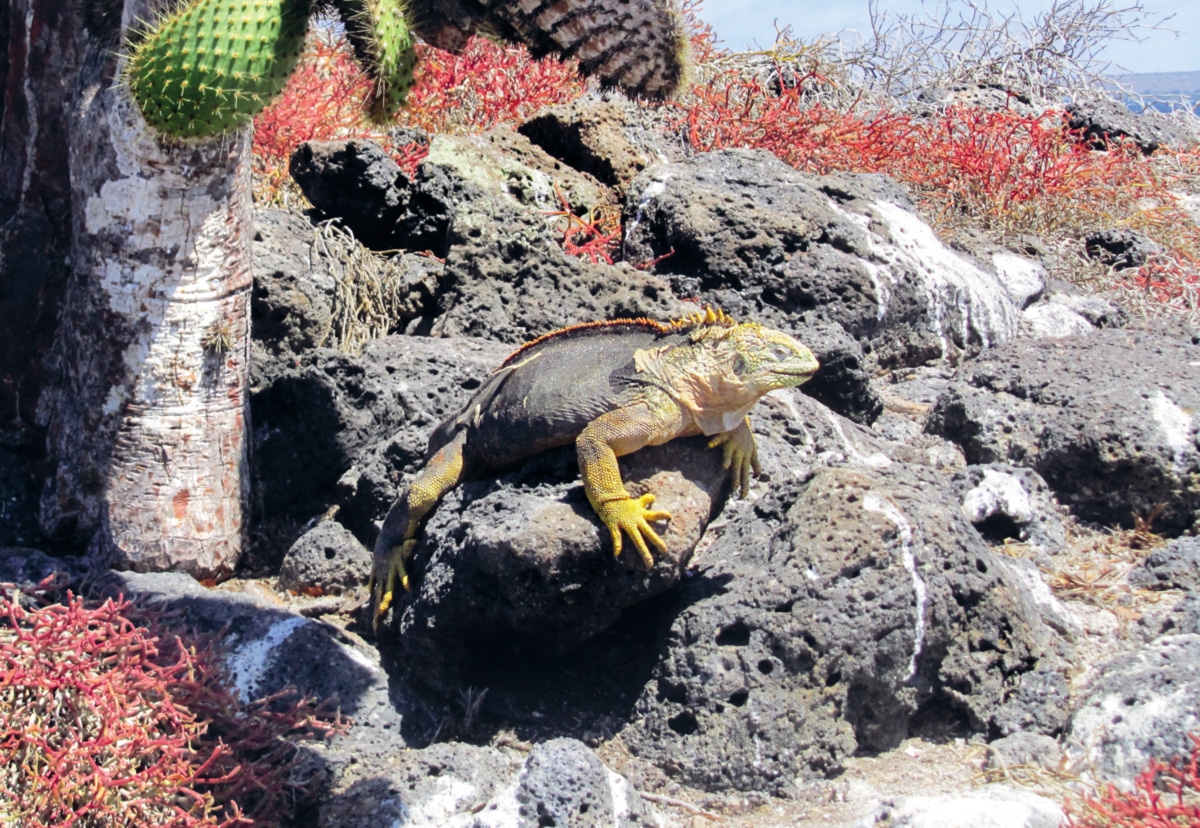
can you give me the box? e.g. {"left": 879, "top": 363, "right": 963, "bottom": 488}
{"left": 625, "top": 150, "right": 1016, "bottom": 366}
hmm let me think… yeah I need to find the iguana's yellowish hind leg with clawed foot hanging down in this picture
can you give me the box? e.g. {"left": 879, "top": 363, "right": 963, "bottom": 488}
{"left": 368, "top": 432, "right": 467, "bottom": 624}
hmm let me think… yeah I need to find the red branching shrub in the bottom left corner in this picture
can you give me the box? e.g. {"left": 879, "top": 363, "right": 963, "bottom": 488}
{"left": 0, "top": 584, "right": 348, "bottom": 828}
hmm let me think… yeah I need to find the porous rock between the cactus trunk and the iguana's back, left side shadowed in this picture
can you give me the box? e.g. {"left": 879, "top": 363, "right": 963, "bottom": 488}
{"left": 251, "top": 336, "right": 509, "bottom": 518}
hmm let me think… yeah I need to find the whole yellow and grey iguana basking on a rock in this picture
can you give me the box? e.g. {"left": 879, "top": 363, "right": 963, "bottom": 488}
{"left": 371, "top": 310, "right": 818, "bottom": 619}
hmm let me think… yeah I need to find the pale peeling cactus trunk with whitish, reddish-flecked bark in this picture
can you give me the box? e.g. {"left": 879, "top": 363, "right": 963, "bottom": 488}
{"left": 38, "top": 0, "right": 252, "bottom": 577}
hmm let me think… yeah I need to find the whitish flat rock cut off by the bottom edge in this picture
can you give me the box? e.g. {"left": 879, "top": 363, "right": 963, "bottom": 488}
{"left": 856, "top": 785, "right": 1063, "bottom": 828}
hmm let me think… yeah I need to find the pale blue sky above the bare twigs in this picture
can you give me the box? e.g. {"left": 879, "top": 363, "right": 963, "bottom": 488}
{"left": 700, "top": 0, "right": 1200, "bottom": 74}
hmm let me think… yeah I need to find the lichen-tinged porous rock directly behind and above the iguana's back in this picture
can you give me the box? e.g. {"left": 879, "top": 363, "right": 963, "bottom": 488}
{"left": 401, "top": 130, "right": 695, "bottom": 344}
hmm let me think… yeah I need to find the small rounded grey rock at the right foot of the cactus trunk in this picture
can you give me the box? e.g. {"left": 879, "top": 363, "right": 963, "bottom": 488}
{"left": 278, "top": 521, "right": 371, "bottom": 596}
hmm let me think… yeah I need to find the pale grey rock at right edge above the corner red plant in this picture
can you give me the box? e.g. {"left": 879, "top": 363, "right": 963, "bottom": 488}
{"left": 1064, "top": 635, "right": 1200, "bottom": 787}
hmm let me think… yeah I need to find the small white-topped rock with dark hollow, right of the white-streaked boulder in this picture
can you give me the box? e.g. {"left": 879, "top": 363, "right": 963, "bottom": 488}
{"left": 952, "top": 463, "right": 1067, "bottom": 554}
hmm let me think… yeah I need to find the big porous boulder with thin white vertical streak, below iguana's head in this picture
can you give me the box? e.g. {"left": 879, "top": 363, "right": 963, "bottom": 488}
{"left": 622, "top": 458, "right": 1050, "bottom": 793}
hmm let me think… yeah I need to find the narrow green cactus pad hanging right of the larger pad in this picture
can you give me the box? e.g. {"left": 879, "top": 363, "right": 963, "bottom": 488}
{"left": 336, "top": 0, "right": 416, "bottom": 126}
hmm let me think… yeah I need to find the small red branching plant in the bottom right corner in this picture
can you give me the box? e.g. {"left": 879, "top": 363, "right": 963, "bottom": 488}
{"left": 1067, "top": 734, "right": 1200, "bottom": 828}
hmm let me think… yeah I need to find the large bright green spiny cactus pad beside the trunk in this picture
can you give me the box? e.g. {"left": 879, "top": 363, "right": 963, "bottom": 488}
{"left": 126, "top": 0, "right": 310, "bottom": 138}
